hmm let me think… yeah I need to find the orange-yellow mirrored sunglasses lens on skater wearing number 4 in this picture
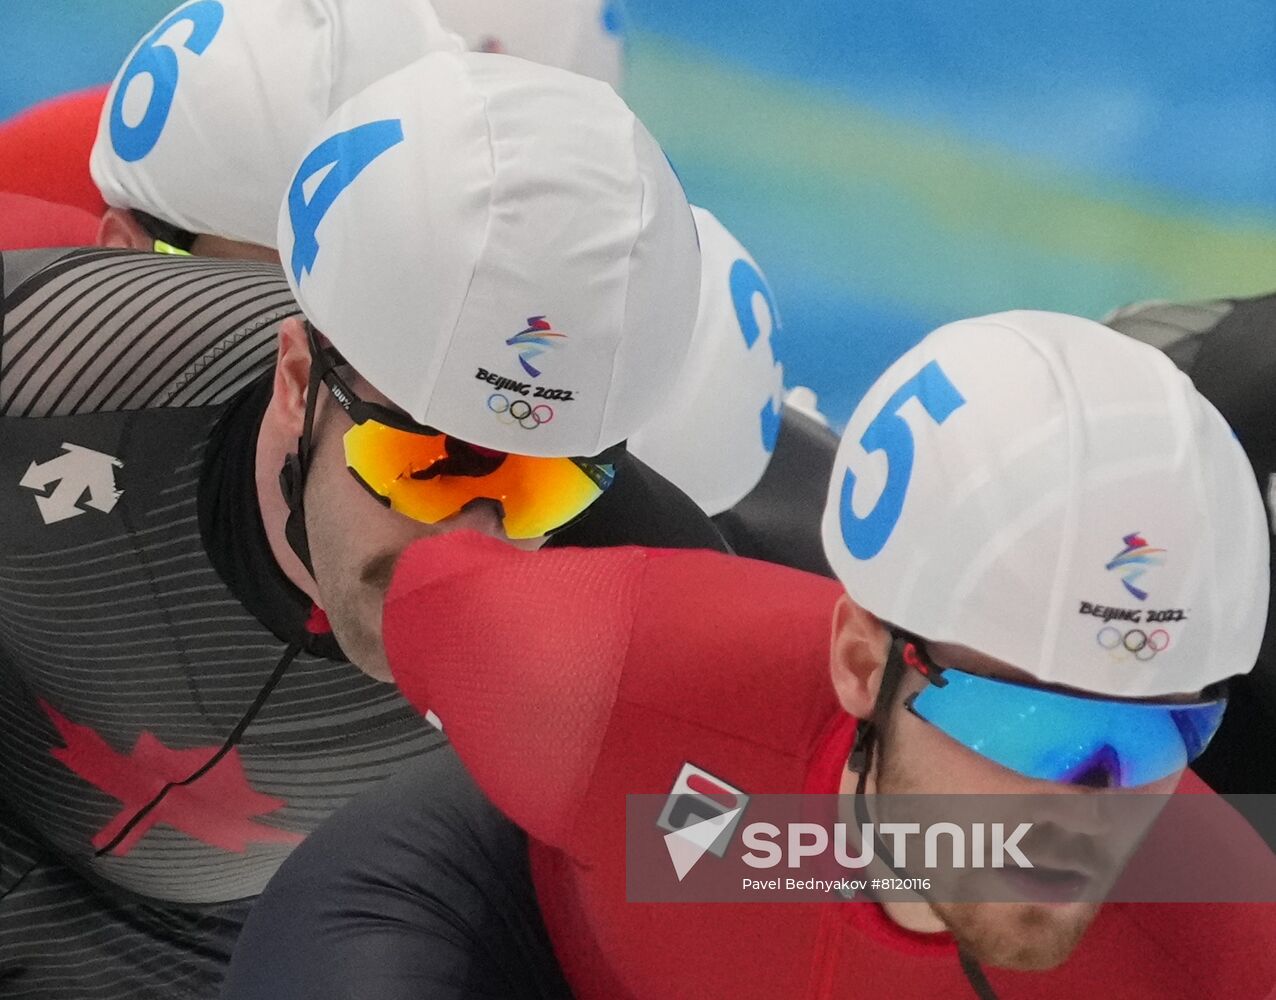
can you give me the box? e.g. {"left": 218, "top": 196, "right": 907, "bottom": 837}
{"left": 345, "top": 421, "right": 609, "bottom": 538}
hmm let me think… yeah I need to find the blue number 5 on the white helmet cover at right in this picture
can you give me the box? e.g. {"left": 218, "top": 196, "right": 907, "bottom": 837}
{"left": 841, "top": 361, "right": 966, "bottom": 559}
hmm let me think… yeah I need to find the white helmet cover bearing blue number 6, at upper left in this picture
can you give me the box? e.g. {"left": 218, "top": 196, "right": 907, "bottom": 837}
{"left": 89, "top": 0, "right": 463, "bottom": 246}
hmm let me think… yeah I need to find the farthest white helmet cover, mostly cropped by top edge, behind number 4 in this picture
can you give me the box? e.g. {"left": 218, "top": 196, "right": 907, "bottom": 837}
{"left": 434, "top": 0, "right": 624, "bottom": 91}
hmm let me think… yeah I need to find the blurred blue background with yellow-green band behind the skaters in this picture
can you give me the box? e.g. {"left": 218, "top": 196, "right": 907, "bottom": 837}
{"left": 0, "top": 0, "right": 1276, "bottom": 425}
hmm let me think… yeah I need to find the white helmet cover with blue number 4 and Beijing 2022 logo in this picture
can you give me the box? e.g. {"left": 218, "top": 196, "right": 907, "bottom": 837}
{"left": 279, "top": 52, "right": 701, "bottom": 455}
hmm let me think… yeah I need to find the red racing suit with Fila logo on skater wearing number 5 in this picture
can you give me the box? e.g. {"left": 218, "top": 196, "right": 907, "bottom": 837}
{"left": 384, "top": 533, "right": 1276, "bottom": 1000}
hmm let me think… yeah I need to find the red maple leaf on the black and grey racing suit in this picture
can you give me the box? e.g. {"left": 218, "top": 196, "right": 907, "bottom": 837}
{"left": 40, "top": 700, "right": 304, "bottom": 855}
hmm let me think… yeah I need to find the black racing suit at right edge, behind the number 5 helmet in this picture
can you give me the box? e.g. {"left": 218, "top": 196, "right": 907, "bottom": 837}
{"left": 1105, "top": 295, "right": 1276, "bottom": 793}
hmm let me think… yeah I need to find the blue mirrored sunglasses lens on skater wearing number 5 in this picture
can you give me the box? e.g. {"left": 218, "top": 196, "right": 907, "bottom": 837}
{"left": 911, "top": 668, "right": 1228, "bottom": 788}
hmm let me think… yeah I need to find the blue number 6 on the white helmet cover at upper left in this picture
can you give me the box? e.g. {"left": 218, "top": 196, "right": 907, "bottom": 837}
{"left": 111, "top": 0, "right": 226, "bottom": 163}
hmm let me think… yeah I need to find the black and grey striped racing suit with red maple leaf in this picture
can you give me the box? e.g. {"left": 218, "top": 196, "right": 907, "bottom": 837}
{"left": 0, "top": 249, "right": 722, "bottom": 1000}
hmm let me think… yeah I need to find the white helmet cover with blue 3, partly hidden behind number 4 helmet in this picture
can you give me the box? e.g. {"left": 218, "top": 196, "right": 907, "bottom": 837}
{"left": 629, "top": 205, "right": 783, "bottom": 514}
